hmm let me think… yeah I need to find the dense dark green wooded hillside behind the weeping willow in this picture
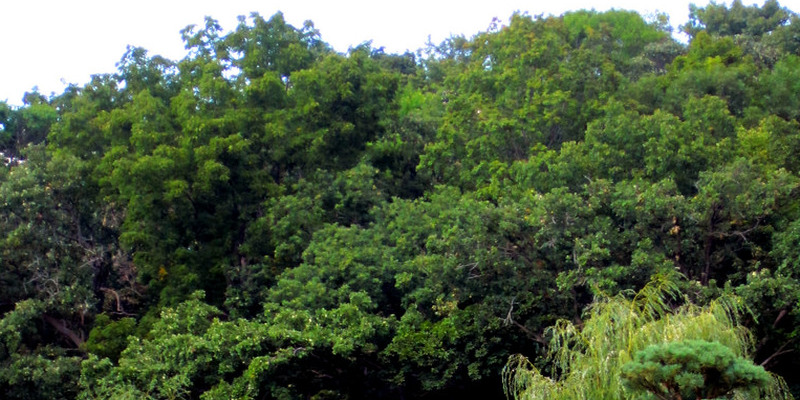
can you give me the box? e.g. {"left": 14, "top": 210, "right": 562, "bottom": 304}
{"left": 0, "top": 0, "right": 800, "bottom": 400}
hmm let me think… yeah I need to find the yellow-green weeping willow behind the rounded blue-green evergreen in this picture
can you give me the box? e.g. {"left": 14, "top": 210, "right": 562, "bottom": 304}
{"left": 503, "top": 276, "right": 792, "bottom": 400}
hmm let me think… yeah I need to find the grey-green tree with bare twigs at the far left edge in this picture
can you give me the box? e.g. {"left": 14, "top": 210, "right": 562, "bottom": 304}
{"left": 0, "top": 145, "right": 117, "bottom": 399}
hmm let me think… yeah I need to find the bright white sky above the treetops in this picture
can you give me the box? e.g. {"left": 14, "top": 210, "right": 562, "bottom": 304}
{"left": 0, "top": 0, "right": 788, "bottom": 105}
